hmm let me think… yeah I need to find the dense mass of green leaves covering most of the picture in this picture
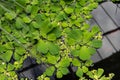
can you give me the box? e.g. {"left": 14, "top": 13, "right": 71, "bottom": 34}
{"left": 0, "top": 0, "right": 113, "bottom": 80}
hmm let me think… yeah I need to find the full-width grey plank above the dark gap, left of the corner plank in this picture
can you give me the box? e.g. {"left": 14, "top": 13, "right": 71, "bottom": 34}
{"left": 92, "top": 6, "right": 117, "bottom": 32}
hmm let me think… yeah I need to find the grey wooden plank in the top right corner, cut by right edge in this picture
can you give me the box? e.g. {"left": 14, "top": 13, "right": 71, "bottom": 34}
{"left": 101, "top": 2, "right": 120, "bottom": 26}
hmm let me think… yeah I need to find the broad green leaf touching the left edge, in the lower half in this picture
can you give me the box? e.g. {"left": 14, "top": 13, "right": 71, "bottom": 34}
{"left": 0, "top": 50, "right": 13, "bottom": 62}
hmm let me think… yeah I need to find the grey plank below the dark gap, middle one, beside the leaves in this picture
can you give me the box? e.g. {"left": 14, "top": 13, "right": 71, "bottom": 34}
{"left": 98, "top": 37, "right": 116, "bottom": 59}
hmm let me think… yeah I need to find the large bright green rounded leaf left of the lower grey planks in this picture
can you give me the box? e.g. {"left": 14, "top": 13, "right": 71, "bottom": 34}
{"left": 79, "top": 46, "right": 91, "bottom": 60}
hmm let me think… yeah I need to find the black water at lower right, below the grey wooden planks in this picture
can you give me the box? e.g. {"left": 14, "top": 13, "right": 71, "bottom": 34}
{"left": 91, "top": 52, "right": 120, "bottom": 80}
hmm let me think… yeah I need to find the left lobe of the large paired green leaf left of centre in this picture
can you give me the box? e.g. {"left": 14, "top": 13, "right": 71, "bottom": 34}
{"left": 37, "top": 40, "right": 48, "bottom": 54}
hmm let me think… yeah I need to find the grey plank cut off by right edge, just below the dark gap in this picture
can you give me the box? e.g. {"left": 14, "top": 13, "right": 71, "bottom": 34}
{"left": 107, "top": 31, "right": 120, "bottom": 51}
